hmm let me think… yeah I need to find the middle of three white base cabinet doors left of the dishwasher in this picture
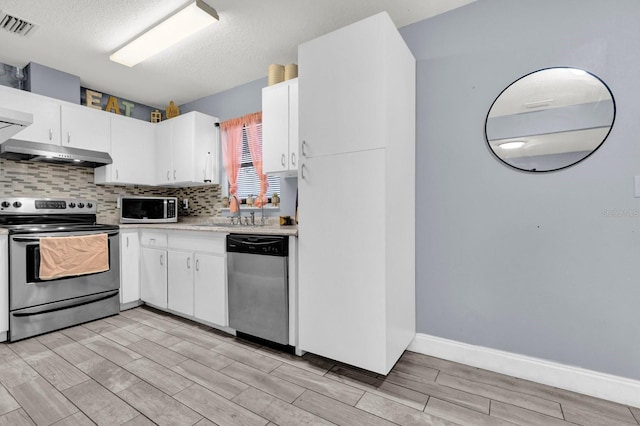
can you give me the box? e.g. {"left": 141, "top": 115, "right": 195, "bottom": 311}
{"left": 167, "top": 250, "right": 194, "bottom": 316}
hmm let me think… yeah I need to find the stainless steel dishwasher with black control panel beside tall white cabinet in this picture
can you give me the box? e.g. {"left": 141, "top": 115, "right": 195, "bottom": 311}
{"left": 227, "top": 234, "right": 289, "bottom": 345}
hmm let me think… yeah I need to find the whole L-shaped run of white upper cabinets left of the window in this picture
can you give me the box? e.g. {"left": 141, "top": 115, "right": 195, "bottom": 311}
{"left": 0, "top": 84, "right": 220, "bottom": 187}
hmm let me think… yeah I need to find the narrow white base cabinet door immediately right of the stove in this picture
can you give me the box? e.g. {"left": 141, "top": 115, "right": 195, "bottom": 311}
{"left": 120, "top": 231, "right": 140, "bottom": 304}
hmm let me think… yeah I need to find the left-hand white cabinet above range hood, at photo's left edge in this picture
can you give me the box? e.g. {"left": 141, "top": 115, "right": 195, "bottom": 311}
{"left": 0, "top": 85, "right": 60, "bottom": 145}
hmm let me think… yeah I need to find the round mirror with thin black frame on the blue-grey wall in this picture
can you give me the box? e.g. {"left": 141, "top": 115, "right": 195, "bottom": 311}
{"left": 485, "top": 68, "right": 616, "bottom": 172}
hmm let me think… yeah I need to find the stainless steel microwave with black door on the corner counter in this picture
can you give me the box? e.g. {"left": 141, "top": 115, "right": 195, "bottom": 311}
{"left": 118, "top": 197, "right": 178, "bottom": 223}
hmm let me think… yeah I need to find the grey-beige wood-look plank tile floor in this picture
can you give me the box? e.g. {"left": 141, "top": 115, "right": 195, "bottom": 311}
{"left": 0, "top": 307, "right": 640, "bottom": 426}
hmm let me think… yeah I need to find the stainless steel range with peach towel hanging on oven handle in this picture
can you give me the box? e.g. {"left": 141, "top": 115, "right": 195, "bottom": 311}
{"left": 0, "top": 198, "right": 120, "bottom": 341}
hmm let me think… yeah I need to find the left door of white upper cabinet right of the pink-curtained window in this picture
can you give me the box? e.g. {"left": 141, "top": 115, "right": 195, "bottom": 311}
{"left": 262, "top": 83, "right": 290, "bottom": 173}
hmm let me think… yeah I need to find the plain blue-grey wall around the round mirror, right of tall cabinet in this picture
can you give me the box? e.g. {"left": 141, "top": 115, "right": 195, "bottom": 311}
{"left": 401, "top": 0, "right": 640, "bottom": 379}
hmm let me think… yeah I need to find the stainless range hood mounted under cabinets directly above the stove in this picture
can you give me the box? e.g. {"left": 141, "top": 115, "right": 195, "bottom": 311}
{"left": 0, "top": 139, "right": 113, "bottom": 168}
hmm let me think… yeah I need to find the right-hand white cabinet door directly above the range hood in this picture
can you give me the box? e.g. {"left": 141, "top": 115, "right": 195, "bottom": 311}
{"left": 62, "top": 104, "right": 111, "bottom": 152}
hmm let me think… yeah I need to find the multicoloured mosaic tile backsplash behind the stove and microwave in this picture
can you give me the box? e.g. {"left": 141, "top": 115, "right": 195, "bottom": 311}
{"left": 0, "top": 159, "right": 222, "bottom": 223}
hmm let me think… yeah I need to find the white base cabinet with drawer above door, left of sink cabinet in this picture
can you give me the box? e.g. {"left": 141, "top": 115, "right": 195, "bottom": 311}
{"left": 140, "top": 232, "right": 168, "bottom": 309}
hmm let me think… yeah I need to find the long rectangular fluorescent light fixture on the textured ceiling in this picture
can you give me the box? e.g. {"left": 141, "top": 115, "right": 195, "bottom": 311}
{"left": 109, "top": 0, "right": 219, "bottom": 67}
